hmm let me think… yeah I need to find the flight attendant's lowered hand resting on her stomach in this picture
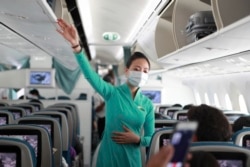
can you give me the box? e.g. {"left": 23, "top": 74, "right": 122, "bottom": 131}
{"left": 111, "top": 125, "right": 140, "bottom": 144}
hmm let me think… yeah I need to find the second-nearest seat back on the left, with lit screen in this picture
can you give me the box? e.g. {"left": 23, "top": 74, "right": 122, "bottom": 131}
{"left": 0, "top": 124, "right": 54, "bottom": 167}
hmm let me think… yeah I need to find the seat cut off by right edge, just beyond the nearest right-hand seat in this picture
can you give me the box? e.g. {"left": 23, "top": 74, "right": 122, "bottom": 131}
{"left": 232, "top": 127, "right": 250, "bottom": 149}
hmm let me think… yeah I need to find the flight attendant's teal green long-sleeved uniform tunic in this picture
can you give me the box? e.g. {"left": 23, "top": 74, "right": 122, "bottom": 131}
{"left": 75, "top": 52, "right": 154, "bottom": 167}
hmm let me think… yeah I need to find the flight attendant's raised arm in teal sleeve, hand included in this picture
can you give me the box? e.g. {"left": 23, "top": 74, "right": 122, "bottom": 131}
{"left": 57, "top": 19, "right": 113, "bottom": 99}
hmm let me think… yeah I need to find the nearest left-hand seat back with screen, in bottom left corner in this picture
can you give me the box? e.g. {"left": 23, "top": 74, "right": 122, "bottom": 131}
{"left": 0, "top": 137, "right": 37, "bottom": 167}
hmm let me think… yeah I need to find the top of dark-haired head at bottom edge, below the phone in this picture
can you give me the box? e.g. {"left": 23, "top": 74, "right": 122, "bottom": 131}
{"left": 189, "top": 151, "right": 219, "bottom": 167}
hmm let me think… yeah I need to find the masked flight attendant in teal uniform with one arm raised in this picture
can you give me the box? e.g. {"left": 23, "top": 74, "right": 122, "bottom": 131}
{"left": 57, "top": 19, "right": 154, "bottom": 167}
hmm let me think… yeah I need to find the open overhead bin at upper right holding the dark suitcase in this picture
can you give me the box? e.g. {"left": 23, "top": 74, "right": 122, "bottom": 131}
{"left": 139, "top": 0, "right": 250, "bottom": 69}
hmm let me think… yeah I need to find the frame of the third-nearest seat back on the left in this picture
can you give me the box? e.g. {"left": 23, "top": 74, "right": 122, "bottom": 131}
{"left": 16, "top": 115, "right": 62, "bottom": 167}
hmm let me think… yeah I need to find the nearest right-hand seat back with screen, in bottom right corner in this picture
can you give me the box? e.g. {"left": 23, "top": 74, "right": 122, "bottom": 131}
{"left": 190, "top": 142, "right": 250, "bottom": 167}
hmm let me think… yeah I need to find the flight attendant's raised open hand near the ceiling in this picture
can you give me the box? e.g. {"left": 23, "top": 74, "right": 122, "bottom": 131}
{"left": 57, "top": 19, "right": 79, "bottom": 47}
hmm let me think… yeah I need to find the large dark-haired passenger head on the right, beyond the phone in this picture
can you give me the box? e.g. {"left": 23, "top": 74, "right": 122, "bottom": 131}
{"left": 187, "top": 104, "right": 232, "bottom": 141}
